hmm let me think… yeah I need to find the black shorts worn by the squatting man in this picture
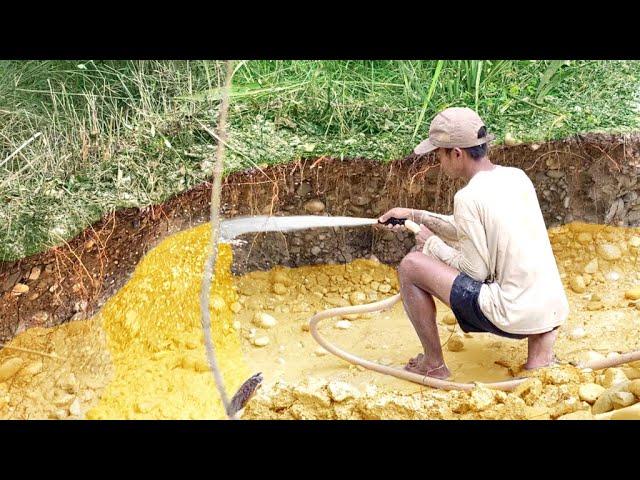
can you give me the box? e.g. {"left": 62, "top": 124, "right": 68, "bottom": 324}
{"left": 449, "top": 272, "right": 528, "bottom": 340}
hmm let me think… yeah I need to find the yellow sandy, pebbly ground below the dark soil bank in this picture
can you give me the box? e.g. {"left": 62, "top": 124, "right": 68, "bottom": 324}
{"left": 0, "top": 224, "right": 640, "bottom": 419}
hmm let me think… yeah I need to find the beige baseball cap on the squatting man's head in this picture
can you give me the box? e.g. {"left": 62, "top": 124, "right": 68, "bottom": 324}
{"left": 413, "top": 107, "right": 495, "bottom": 155}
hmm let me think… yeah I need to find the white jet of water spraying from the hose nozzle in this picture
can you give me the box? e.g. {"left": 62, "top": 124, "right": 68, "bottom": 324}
{"left": 220, "top": 215, "right": 378, "bottom": 241}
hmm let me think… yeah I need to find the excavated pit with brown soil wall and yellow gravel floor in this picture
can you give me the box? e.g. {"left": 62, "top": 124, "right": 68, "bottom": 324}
{"left": 0, "top": 136, "right": 640, "bottom": 418}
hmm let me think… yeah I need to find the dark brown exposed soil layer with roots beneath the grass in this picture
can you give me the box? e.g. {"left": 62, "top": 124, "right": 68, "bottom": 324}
{"left": 0, "top": 135, "right": 640, "bottom": 342}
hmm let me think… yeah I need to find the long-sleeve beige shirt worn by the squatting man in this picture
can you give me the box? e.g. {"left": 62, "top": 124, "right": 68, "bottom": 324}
{"left": 425, "top": 166, "right": 569, "bottom": 334}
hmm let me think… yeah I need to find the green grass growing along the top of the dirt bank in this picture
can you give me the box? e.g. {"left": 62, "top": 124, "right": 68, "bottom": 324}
{"left": 0, "top": 60, "right": 640, "bottom": 260}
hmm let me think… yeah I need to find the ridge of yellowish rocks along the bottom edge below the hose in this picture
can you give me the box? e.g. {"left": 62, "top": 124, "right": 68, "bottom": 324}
{"left": 244, "top": 366, "right": 640, "bottom": 420}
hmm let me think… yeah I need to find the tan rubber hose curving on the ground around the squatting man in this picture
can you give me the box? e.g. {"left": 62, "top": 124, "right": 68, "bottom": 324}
{"left": 309, "top": 220, "right": 640, "bottom": 391}
